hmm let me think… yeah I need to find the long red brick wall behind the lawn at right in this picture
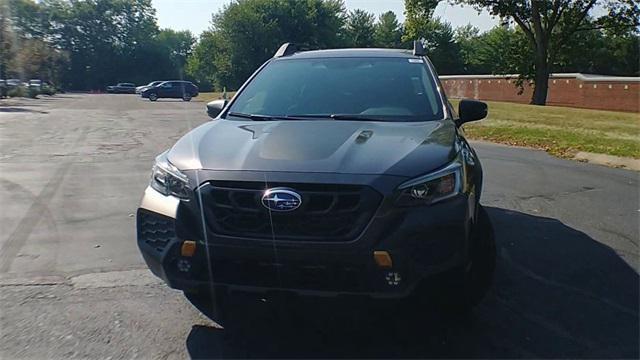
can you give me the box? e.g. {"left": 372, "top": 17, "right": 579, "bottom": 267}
{"left": 440, "top": 74, "right": 640, "bottom": 112}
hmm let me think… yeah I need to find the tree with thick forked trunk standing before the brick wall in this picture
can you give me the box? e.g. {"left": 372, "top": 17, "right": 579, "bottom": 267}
{"left": 456, "top": 0, "right": 640, "bottom": 105}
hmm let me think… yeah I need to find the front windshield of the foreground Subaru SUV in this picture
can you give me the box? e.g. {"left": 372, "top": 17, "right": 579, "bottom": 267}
{"left": 229, "top": 58, "right": 443, "bottom": 121}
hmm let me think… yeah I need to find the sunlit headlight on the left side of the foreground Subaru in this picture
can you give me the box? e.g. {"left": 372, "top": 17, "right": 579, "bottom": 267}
{"left": 150, "top": 152, "right": 191, "bottom": 199}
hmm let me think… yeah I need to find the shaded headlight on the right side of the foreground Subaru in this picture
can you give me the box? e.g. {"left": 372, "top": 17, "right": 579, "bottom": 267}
{"left": 396, "top": 156, "right": 464, "bottom": 206}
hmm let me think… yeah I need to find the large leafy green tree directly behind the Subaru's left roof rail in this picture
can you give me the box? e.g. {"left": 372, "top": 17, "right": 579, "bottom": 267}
{"left": 187, "top": 0, "right": 345, "bottom": 89}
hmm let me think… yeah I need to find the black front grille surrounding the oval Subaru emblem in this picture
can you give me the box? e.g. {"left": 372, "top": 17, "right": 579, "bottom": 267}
{"left": 199, "top": 181, "right": 382, "bottom": 242}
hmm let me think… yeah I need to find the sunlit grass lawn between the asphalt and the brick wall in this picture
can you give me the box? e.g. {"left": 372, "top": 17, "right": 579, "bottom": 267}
{"left": 452, "top": 100, "right": 640, "bottom": 159}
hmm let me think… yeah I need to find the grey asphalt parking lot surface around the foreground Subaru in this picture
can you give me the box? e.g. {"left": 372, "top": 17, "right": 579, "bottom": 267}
{"left": 0, "top": 94, "right": 640, "bottom": 359}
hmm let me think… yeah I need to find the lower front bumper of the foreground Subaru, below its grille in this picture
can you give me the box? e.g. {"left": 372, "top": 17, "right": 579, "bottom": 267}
{"left": 137, "top": 177, "right": 475, "bottom": 298}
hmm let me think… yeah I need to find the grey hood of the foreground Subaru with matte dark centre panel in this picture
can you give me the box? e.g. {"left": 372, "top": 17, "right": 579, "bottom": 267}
{"left": 167, "top": 120, "right": 456, "bottom": 177}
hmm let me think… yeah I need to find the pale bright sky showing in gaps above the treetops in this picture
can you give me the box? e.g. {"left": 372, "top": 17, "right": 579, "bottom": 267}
{"left": 152, "top": 0, "right": 498, "bottom": 35}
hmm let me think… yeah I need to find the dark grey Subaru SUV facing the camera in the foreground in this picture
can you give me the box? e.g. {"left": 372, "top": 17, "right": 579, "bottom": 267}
{"left": 137, "top": 43, "right": 495, "bottom": 325}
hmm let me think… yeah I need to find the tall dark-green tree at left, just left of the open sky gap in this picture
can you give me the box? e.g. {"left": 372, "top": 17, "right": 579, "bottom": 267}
{"left": 51, "top": 0, "right": 159, "bottom": 89}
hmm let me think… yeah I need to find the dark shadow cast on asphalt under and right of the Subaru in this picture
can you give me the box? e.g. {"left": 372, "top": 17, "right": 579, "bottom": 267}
{"left": 186, "top": 208, "right": 640, "bottom": 359}
